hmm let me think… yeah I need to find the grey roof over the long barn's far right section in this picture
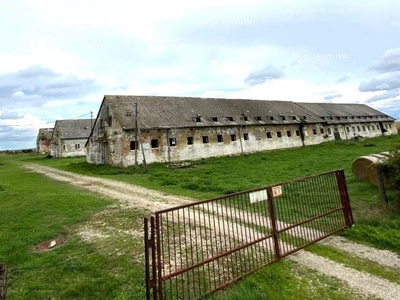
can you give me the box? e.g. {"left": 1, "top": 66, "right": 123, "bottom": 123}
{"left": 297, "top": 102, "right": 394, "bottom": 124}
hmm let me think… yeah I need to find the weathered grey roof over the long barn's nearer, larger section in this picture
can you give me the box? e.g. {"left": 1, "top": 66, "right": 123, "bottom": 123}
{"left": 104, "top": 95, "right": 323, "bottom": 129}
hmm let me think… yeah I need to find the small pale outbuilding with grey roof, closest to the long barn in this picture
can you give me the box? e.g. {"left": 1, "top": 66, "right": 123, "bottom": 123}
{"left": 50, "top": 119, "right": 92, "bottom": 157}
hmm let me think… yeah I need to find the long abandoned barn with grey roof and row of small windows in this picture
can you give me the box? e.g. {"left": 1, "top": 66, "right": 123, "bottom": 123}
{"left": 86, "top": 95, "right": 397, "bottom": 167}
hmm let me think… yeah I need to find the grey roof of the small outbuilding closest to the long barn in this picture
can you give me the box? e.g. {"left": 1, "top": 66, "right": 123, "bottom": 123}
{"left": 52, "top": 119, "right": 92, "bottom": 139}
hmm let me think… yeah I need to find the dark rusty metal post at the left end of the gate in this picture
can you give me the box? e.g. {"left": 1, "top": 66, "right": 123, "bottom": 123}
{"left": 144, "top": 217, "right": 157, "bottom": 300}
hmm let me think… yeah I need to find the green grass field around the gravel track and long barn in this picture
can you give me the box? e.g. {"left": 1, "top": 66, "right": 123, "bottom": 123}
{"left": 0, "top": 135, "right": 400, "bottom": 299}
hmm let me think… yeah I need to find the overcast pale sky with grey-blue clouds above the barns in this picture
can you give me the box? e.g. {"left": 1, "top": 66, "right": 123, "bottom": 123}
{"left": 0, "top": 0, "right": 400, "bottom": 150}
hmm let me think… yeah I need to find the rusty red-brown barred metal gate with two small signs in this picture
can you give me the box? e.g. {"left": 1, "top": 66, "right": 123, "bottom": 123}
{"left": 144, "top": 170, "right": 353, "bottom": 299}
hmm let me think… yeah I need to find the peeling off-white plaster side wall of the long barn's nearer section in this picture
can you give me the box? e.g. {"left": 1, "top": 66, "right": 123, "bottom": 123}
{"left": 110, "top": 125, "right": 312, "bottom": 167}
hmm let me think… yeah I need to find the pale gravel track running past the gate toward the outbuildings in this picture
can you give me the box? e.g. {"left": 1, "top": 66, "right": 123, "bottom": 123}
{"left": 24, "top": 164, "right": 400, "bottom": 299}
